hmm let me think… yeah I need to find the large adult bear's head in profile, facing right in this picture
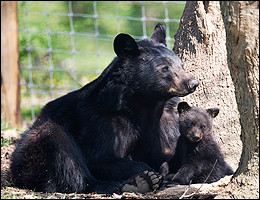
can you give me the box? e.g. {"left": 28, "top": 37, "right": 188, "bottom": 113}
{"left": 114, "top": 23, "right": 199, "bottom": 99}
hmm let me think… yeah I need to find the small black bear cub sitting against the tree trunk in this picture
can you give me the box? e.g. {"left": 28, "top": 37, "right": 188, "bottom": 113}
{"left": 166, "top": 102, "right": 234, "bottom": 184}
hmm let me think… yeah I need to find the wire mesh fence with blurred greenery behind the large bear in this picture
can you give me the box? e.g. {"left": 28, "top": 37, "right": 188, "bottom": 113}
{"left": 18, "top": 1, "right": 185, "bottom": 121}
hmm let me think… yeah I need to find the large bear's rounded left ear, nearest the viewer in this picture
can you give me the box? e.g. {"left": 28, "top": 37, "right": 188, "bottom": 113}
{"left": 114, "top": 33, "right": 140, "bottom": 58}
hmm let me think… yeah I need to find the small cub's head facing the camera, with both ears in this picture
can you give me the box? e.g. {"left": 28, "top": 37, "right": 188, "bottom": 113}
{"left": 178, "top": 102, "right": 219, "bottom": 142}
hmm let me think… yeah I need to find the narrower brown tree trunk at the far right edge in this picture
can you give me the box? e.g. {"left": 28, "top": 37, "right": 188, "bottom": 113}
{"left": 220, "top": 1, "right": 259, "bottom": 198}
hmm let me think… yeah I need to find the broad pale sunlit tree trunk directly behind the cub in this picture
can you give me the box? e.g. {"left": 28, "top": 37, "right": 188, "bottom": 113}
{"left": 173, "top": 1, "right": 242, "bottom": 173}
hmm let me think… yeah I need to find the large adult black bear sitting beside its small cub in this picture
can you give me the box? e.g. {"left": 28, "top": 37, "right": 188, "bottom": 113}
{"left": 11, "top": 23, "right": 199, "bottom": 193}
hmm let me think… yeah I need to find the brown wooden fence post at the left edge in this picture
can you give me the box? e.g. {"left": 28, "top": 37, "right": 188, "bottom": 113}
{"left": 1, "top": 1, "right": 21, "bottom": 126}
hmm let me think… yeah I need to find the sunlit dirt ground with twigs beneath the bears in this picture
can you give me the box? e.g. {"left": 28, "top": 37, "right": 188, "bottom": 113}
{"left": 1, "top": 131, "right": 244, "bottom": 199}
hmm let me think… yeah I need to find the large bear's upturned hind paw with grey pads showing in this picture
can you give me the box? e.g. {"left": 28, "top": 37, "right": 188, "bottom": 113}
{"left": 121, "top": 171, "right": 162, "bottom": 193}
